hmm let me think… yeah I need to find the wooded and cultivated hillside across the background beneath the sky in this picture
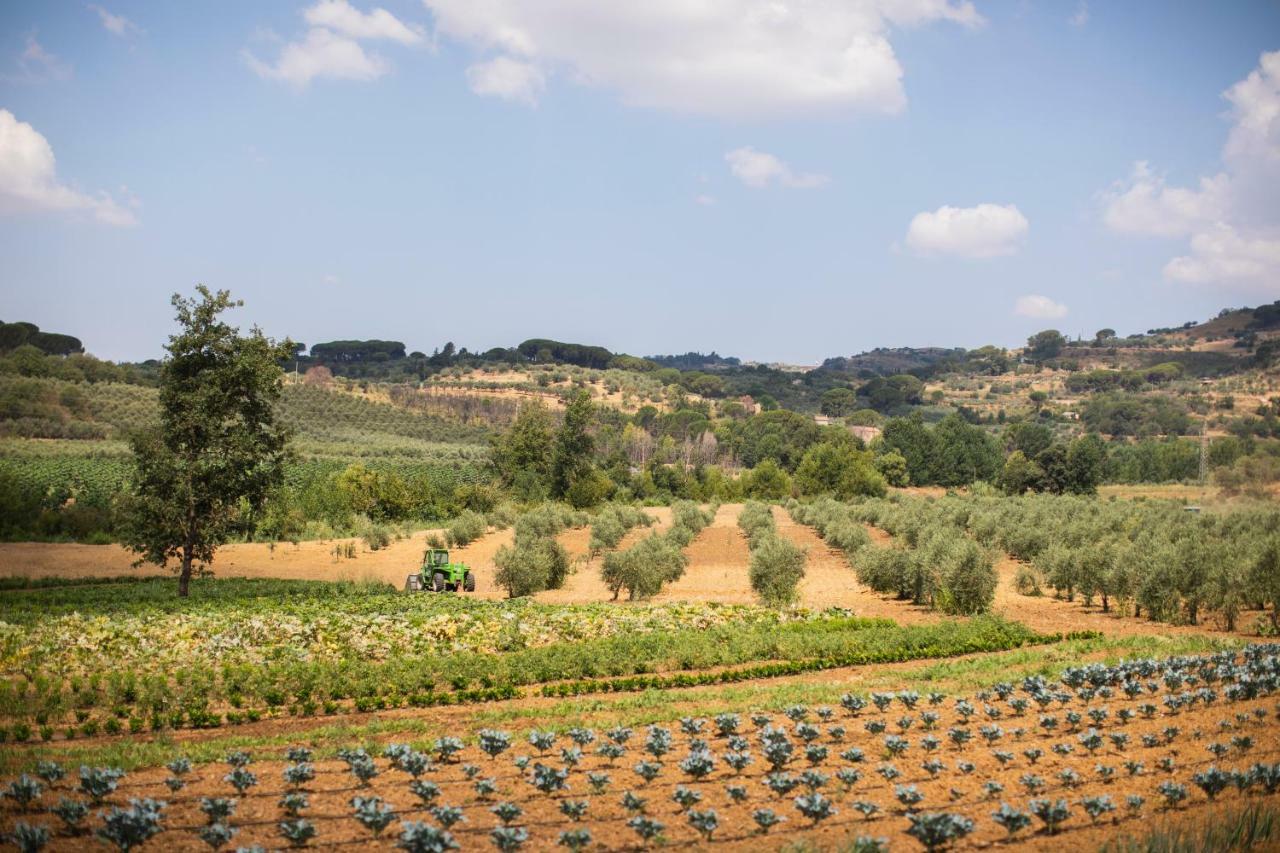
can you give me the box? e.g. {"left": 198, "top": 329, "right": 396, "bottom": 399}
{"left": 0, "top": 295, "right": 1280, "bottom": 540}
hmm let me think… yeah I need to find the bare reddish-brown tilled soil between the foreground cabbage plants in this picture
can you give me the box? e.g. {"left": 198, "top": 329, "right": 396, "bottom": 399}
{"left": 0, "top": 666, "right": 1280, "bottom": 850}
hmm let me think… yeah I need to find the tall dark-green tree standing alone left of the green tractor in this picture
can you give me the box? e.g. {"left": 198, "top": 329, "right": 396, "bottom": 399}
{"left": 124, "top": 284, "right": 293, "bottom": 596}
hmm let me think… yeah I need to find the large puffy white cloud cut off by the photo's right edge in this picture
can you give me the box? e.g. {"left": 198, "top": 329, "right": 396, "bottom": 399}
{"left": 1102, "top": 51, "right": 1280, "bottom": 287}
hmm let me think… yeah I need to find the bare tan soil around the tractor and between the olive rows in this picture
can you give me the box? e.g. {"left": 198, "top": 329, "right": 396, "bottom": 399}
{"left": 0, "top": 503, "right": 1253, "bottom": 637}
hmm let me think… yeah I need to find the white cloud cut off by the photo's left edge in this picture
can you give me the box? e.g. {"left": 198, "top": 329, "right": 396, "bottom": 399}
{"left": 0, "top": 109, "right": 137, "bottom": 225}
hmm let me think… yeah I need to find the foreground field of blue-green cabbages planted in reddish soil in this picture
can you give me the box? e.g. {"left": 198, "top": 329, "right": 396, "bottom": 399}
{"left": 0, "top": 646, "right": 1280, "bottom": 853}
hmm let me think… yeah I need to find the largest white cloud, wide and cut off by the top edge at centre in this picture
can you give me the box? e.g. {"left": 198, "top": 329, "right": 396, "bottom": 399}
{"left": 424, "top": 0, "right": 983, "bottom": 118}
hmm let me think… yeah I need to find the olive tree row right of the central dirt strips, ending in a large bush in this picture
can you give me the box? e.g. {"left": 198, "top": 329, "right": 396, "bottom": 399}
{"left": 790, "top": 498, "right": 996, "bottom": 615}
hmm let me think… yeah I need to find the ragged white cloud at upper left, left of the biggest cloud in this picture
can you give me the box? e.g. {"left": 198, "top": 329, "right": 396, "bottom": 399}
{"left": 249, "top": 0, "right": 422, "bottom": 88}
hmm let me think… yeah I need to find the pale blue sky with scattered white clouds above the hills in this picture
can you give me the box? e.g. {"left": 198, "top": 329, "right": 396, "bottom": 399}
{"left": 0, "top": 0, "right": 1280, "bottom": 364}
